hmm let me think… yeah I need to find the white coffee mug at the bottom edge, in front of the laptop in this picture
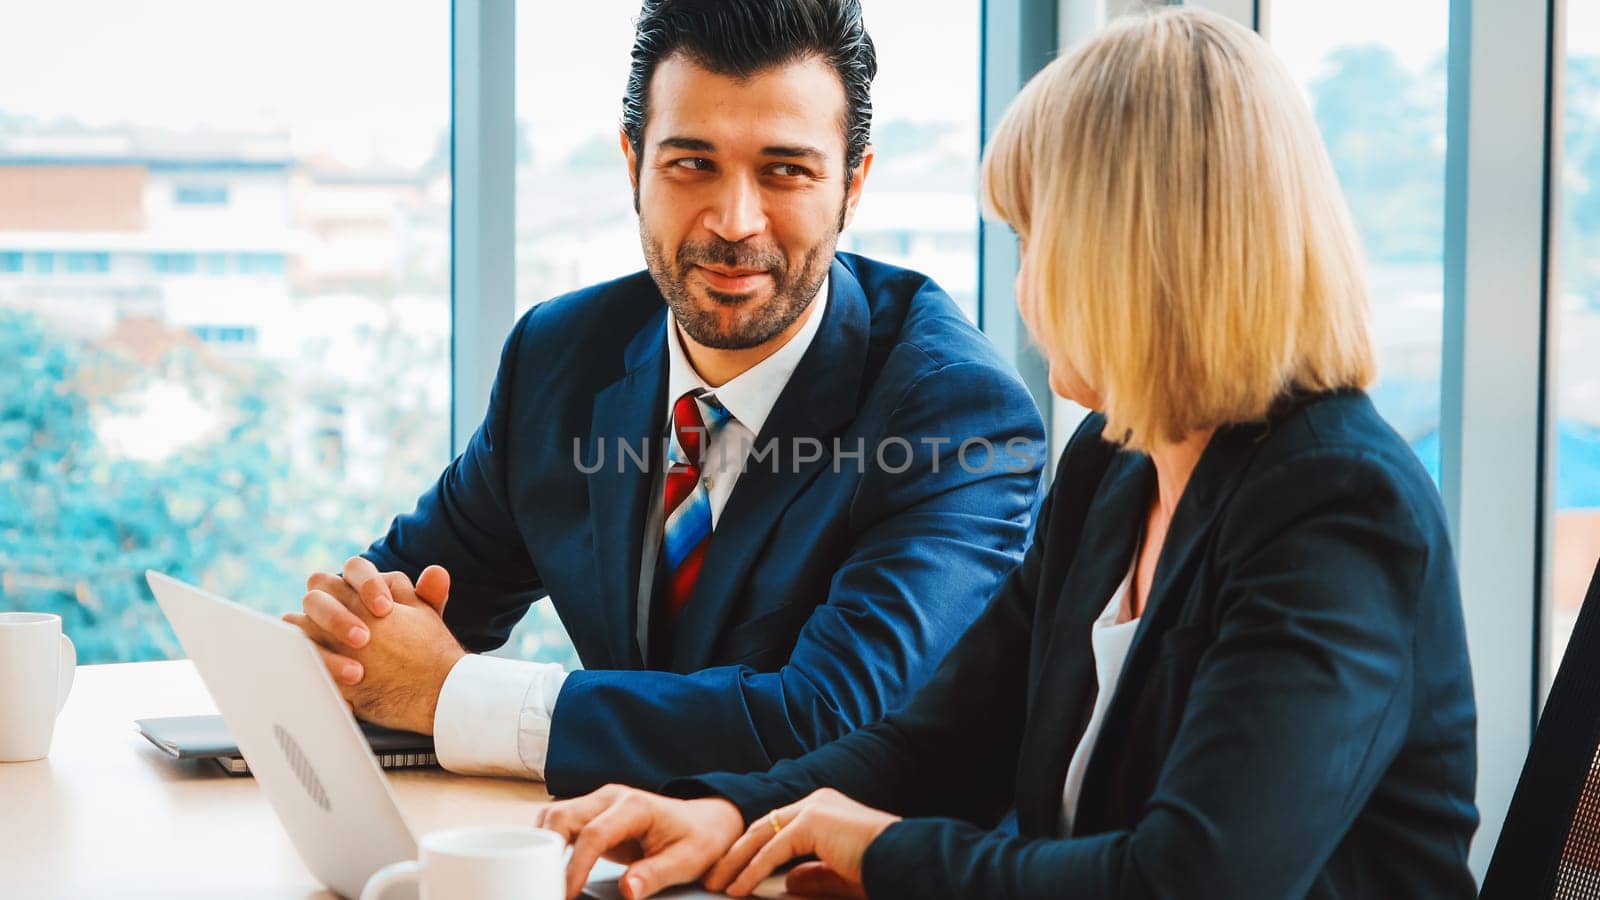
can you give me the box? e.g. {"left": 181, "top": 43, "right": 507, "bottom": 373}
{"left": 362, "top": 825, "right": 566, "bottom": 900}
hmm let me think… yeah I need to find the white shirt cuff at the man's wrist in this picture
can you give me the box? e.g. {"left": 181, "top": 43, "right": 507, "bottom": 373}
{"left": 434, "top": 653, "right": 566, "bottom": 781}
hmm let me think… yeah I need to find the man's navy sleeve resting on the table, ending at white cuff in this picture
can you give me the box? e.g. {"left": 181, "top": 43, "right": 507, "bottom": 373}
{"left": 546, "top": 357, "right": 1043, "bottom": 796}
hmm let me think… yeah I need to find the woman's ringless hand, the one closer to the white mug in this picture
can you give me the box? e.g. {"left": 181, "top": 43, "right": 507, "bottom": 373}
{"left": 534, "top": 785, "right": 744, "bottom": 900}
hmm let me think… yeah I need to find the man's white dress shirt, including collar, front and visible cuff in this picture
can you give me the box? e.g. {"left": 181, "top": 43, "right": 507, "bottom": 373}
{"left": 434, "top": 279, "right": 829, "bottom": 780}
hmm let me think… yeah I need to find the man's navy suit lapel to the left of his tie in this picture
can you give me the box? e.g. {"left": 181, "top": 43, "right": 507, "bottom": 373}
{"left": 584, "top": 304, "right": 667, "bottom": 668}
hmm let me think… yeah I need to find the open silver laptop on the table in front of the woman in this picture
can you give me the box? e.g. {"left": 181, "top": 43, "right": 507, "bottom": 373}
{"left": 144, "top": 572, "right": 718, "bottom": 898}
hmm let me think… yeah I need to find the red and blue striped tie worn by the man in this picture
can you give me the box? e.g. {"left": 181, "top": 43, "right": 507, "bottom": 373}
{"left": 661, "top": 388, "right": 733, "bottom": 621}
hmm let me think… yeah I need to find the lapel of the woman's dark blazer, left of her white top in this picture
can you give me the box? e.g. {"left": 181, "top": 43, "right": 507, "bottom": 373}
{"left": 1018, "top": 453, "right": 1155, "bottom": 834}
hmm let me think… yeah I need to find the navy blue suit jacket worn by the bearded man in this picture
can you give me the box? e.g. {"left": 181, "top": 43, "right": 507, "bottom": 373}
{"left": 366, "top": 253, "right": 1045, "bottom": 794}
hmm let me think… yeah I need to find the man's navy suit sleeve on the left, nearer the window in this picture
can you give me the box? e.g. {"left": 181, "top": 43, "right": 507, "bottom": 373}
{"left": 362, "top": 307, "right": 544, "bottom": 652}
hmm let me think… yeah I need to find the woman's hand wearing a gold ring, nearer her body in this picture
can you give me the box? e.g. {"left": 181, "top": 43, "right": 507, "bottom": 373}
{"left": 706, "top": 788, "right": 899, "bottom": 897}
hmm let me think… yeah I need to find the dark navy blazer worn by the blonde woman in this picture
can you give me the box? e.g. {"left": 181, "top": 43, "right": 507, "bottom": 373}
{"left": 666, "top": 391, "right": 1477, "bottom": 900}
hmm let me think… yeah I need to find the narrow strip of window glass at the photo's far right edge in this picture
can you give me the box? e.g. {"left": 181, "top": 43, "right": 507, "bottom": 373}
{"left": 1544, "top": 0, "right": 1600, "bottom": 672}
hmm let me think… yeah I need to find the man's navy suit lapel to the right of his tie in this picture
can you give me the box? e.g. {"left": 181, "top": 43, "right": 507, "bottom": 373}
{"left": 672, "top": 259, "right": 870, "bottom": 673}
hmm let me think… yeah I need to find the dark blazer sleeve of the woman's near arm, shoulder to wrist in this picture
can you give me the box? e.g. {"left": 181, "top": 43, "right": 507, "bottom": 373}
{"left": 862, "top": 450, "right": 1433, "bottom": 900}
